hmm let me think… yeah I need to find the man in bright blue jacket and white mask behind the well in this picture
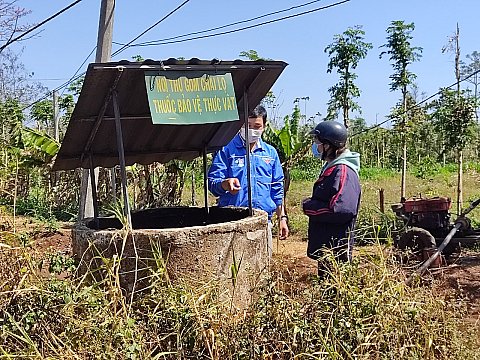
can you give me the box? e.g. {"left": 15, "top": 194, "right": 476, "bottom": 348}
{"left": 208, "top": 105, "right": 288, "bottom": 255}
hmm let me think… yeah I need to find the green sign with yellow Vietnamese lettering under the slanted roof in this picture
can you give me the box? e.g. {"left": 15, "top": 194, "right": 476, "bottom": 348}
{"left": 145, "top": 71, "right": 238, "bottom": 125}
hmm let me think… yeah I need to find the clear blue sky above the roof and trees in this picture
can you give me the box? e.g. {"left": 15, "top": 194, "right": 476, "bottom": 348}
{"left": 10, "top": 0, "right": 480, "bottom": 124}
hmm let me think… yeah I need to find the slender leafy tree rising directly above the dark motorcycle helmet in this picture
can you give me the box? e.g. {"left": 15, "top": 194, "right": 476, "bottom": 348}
{"left": 325, "top": 26, "right": 372, "bottom": 128}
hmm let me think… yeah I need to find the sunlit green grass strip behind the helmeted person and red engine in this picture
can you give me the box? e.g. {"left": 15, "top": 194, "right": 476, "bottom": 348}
{"left": 287, "top": 165, "right": 480, "bottom": 242}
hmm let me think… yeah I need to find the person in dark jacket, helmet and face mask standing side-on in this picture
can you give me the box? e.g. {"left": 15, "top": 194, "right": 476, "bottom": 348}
{"left": 303, "top": 121, "right": 361, "bottom": 275}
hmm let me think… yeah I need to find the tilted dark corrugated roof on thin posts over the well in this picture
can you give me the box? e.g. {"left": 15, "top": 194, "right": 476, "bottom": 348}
{"left": 53, "top": 59, "right": 287, "bottom": 170}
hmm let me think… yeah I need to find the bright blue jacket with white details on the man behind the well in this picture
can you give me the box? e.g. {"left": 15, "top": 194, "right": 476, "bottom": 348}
{"left": 208, "top": 134, "right": 283, "bottom": 219}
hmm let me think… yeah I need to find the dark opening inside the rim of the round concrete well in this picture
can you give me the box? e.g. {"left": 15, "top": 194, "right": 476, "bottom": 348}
{"left": 87, "top": 206, "right": 248, "bottom": 230}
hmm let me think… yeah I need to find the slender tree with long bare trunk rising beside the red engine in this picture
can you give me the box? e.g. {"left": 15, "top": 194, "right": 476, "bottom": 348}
{"left": 380, "top": 20, "right": 422, "bottom": 197}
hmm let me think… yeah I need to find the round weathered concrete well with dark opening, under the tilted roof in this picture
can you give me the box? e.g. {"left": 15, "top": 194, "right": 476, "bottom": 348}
{"left": 72, "top": 207, "right": 269, "bottom": 304}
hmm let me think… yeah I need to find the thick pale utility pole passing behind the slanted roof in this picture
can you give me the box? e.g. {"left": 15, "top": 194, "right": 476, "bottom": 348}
{"left": 78, "top": 0, "right": 115, "bottom": 220}
